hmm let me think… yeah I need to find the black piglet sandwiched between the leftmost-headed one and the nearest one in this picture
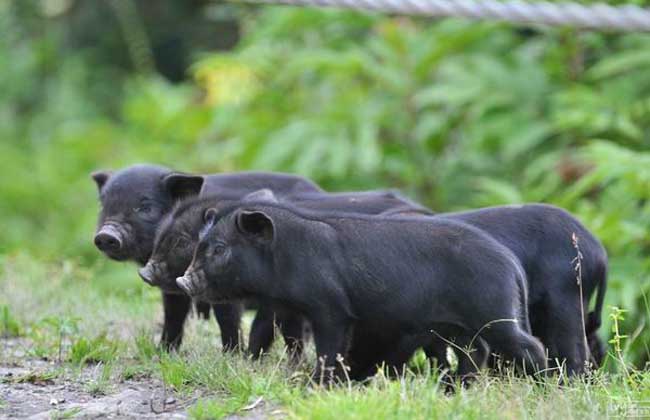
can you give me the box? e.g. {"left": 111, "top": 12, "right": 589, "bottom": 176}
{"left": 141, "top": 189, "right": 430, "bottom": 357}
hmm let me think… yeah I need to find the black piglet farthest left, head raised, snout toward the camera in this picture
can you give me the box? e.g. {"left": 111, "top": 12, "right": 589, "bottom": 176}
{"left": 92, "top": 165, "right": 320, "bottom": 349}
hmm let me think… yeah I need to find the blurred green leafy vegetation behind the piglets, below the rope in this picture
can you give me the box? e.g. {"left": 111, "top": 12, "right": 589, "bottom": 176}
{"left": 0, "top": 0, "right": 650, "bottom": 416}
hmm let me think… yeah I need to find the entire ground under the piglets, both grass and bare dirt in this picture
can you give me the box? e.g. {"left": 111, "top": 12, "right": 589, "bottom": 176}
{"left": 0, "top": 255, "right": 650, "bottom": 420}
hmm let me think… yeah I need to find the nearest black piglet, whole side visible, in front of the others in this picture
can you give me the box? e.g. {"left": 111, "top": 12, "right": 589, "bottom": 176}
{"left": 177, "top": 203, "right": 546, "bottom": 384}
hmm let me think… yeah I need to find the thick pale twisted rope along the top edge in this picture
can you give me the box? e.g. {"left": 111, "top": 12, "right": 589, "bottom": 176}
{"left": 239, "top": 0, "right": 650, "bottom": 31}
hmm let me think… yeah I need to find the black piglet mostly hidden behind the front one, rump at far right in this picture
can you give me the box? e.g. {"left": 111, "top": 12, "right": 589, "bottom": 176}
{"left": 350, "top": 204, "right": 607, "bottom": 379}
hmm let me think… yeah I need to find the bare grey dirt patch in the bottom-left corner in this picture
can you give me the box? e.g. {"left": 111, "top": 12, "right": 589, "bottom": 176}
{"left": 0, "top": 340, "right": 194, "bottom": 419}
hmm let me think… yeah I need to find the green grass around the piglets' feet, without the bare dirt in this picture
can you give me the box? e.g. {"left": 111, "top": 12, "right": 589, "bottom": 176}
{"left": 0, "top": 255, "right": 650, "bottom": 420}
